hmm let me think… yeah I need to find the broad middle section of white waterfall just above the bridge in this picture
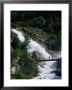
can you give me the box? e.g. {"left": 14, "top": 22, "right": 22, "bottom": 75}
{"left": 28, "top": 39, "right": 52, "bottom": 59}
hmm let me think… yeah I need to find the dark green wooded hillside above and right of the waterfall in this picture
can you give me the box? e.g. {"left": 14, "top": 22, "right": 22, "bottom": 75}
{"left": 11, "top": 11, "right": 61, "bottom": 50}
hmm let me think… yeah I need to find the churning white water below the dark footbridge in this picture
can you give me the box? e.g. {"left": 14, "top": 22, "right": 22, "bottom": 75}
{"left": 34, "top": 61, "right": 55, "bottom": 79}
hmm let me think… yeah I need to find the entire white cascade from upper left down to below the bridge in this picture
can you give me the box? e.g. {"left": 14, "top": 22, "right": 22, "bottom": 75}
{"left": 12, "top": 29, "right": 59, "bottom": 79}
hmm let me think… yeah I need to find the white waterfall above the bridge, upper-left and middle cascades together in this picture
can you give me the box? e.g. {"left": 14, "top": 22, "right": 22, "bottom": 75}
{"left": 12, "top": 29, "right": 52, "bottom": 59}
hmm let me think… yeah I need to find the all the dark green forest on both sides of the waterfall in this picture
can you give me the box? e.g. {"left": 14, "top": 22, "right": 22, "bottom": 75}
{"left": 11, "top": 11, "right": 61, "bottom": 79}
